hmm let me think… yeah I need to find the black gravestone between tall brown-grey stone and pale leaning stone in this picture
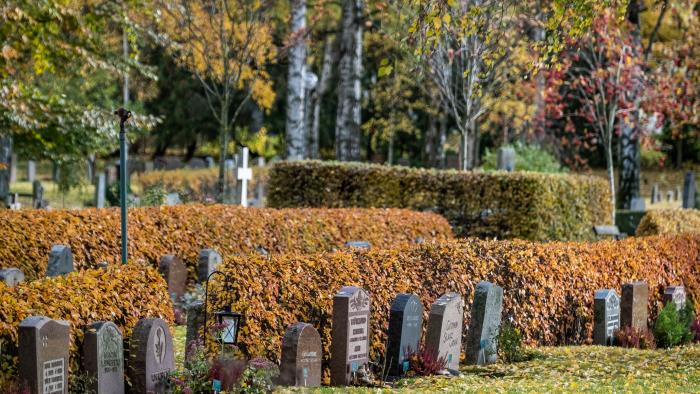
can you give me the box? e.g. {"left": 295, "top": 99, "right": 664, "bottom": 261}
{"left": 386, "top": 294, "right": 423, "bottom": 376}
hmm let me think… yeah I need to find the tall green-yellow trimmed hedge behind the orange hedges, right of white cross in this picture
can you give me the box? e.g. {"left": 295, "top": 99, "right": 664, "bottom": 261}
{"left": 267, "top": 161, "right": 612, "bottom": 241}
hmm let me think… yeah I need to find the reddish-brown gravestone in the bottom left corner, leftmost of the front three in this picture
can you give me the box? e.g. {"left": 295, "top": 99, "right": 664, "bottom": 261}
{"left": 19, "top": 316, "right": 70, "bottom": 394}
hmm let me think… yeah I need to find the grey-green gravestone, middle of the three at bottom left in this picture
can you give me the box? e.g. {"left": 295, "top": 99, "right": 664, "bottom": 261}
{"left": 83, "top": 321, "right": 124, "bottom": 394}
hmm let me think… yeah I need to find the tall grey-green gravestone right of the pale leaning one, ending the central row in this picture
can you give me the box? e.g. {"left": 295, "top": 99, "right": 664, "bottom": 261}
{"left": 466, "top": 282, "right": 503, "bottom": 365}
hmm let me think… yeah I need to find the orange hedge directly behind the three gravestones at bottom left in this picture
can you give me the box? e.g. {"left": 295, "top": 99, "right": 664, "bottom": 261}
{"left": 0, "top": 263, "right": 173, "bottom": 380}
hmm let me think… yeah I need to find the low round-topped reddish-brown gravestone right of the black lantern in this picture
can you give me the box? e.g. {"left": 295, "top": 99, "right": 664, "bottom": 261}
{"left": 279, "top": 323, "right": 323, "bottom": 387}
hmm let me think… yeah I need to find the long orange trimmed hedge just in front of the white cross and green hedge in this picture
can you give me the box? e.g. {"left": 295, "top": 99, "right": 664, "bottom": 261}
{"left": 0, "top": 205, "right": 452, "bottom": 279}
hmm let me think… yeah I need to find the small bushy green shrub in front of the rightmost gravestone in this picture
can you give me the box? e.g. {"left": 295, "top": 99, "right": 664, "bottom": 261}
{"left": 654, "top": 302, "right": 695, "bottom": 348}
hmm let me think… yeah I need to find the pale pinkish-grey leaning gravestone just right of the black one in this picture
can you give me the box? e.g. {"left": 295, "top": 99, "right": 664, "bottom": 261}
{"left": 425, "top": 293, "right": 464, "bottom": 371}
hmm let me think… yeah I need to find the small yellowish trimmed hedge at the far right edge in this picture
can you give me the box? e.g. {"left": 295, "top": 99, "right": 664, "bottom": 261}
{"left": 637, "top": 209, "right": 700, "bottom": 236}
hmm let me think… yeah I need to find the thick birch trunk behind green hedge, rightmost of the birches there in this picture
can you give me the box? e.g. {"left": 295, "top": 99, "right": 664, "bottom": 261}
{"left": 335, "top": 0, "right": 362, "bottom": 161}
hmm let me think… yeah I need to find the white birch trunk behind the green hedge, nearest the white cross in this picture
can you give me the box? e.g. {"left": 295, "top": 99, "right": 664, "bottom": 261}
{"left": 286, "top": 0, "right": 307, "bottom": 160}
